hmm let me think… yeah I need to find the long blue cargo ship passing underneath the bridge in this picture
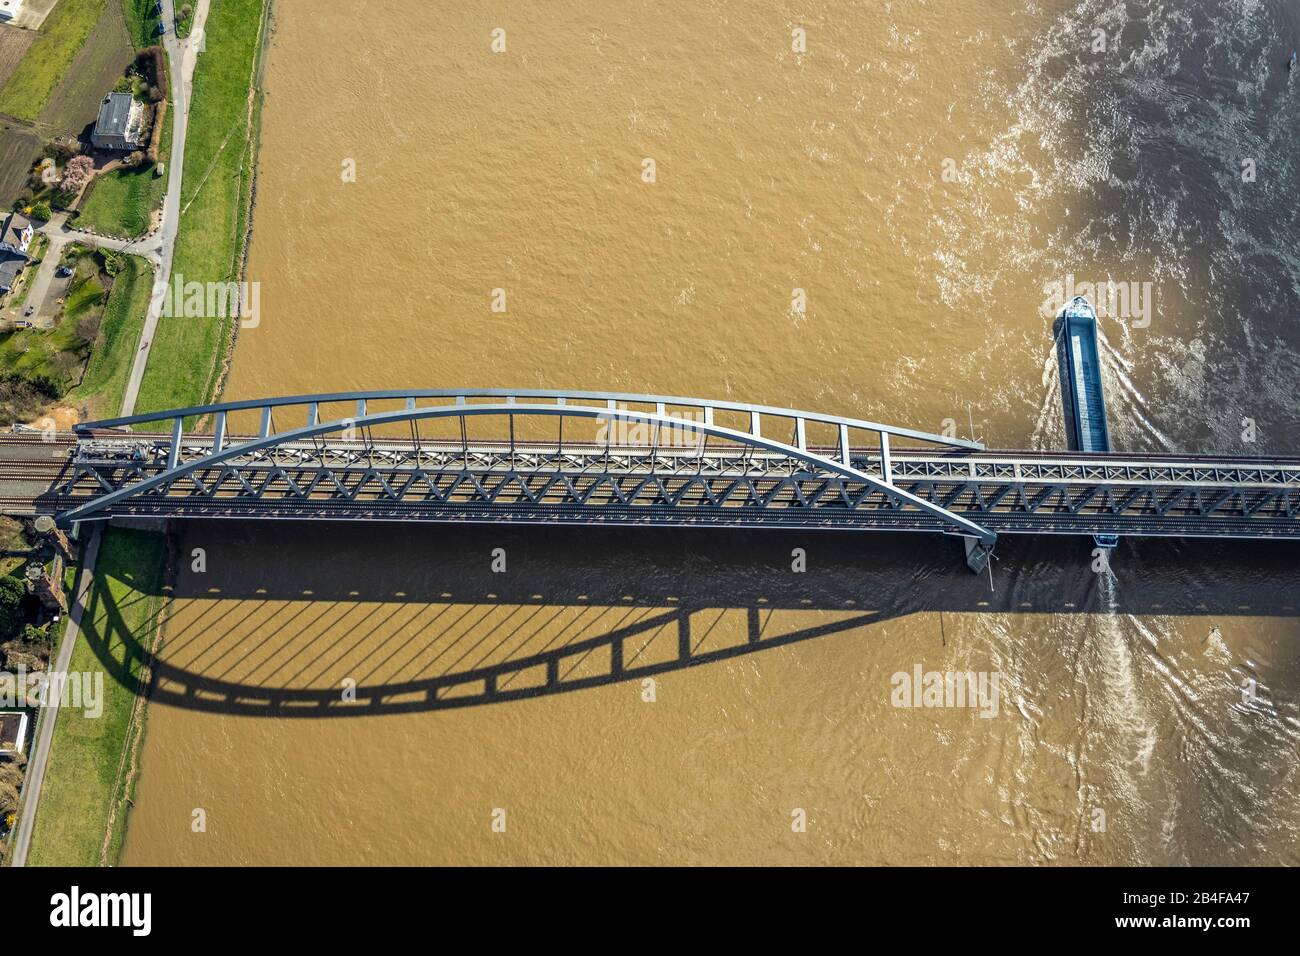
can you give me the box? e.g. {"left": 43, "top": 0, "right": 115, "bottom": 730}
{"left": 1057, "top": 295, "right": 1119, "bottom": 548}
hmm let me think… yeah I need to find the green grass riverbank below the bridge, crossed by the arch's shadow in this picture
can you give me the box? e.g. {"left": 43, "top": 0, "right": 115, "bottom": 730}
{"left": 27, "top": 528, "right": 165, "bottom": 866}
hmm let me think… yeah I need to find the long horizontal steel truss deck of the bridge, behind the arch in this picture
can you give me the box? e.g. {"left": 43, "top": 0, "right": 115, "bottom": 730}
{"left": 60, "top": 441, "right": 1300, "bottom": 537}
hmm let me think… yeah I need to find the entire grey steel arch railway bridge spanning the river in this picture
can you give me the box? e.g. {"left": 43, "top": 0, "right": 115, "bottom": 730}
{"left": 44, "top": 389, "right": 1300, "bottom": 568}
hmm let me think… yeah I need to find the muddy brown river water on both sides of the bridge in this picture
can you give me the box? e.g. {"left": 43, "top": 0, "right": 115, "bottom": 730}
{"left": 116, "top": 0, "right": 1300, "bottom": 865}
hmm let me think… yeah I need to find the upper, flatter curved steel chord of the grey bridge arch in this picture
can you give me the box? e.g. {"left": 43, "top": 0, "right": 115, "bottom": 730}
{"left": 75, "top": 389, "right": 984, "bottom": 451}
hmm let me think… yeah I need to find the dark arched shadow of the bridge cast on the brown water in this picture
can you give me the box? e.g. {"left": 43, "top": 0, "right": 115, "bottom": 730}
{"left": 76, "top": 522, "right": 1300, "bottom": 718}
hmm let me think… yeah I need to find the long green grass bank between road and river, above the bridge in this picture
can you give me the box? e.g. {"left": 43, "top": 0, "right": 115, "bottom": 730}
{"left": 135, "top": 0, "right": 264, "bottom": 412}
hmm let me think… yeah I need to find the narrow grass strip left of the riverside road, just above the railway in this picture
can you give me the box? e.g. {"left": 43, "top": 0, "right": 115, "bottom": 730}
{"left": 68, "top": 256, "right": 153, "bottom": 418}
